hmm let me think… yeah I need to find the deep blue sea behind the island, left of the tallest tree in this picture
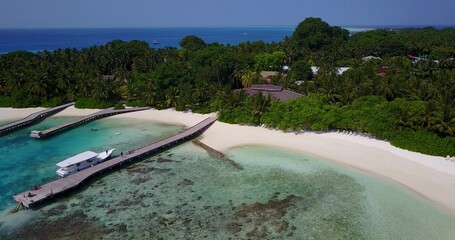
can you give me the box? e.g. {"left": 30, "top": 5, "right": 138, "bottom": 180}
{"left": 0, "top": 27, "right": 294, "bottom": 53}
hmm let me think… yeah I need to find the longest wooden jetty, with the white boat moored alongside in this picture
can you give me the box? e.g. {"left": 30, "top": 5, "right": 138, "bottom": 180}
{"left": 13, "top": 117, "right": 216, "bottom": 208}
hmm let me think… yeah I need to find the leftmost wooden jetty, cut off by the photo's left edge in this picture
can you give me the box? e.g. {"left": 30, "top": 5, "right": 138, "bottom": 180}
{"left": 0, "top": 102, "right": 74, "bottom": 136}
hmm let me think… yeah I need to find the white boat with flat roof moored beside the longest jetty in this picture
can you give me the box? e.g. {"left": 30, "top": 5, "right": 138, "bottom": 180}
{"left": 57, "top": 148, "right": 115, "bottom": 177}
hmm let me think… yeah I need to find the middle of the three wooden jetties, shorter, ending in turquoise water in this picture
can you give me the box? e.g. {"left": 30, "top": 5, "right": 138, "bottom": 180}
{"left": 30, "top": 107, "right": 150, "bottom": 138}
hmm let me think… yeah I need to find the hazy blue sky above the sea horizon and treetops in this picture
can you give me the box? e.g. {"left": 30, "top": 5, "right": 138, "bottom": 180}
{"left": 0, "top": 0, "right": 455, "bottom": 28}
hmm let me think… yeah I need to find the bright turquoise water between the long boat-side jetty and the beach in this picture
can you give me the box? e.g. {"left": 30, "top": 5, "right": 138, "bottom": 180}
{"left": 0, "top": 117, "right": 181, "bottom": 210}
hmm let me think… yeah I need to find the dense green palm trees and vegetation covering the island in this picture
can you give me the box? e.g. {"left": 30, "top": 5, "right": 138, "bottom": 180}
{"left": 0, "top": 18, "right": 455, "bottom": 156}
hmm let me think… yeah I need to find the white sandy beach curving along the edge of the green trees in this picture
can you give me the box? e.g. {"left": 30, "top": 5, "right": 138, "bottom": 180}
{"left": 0, "top": 107, "right": 455, "bottom": 212}
